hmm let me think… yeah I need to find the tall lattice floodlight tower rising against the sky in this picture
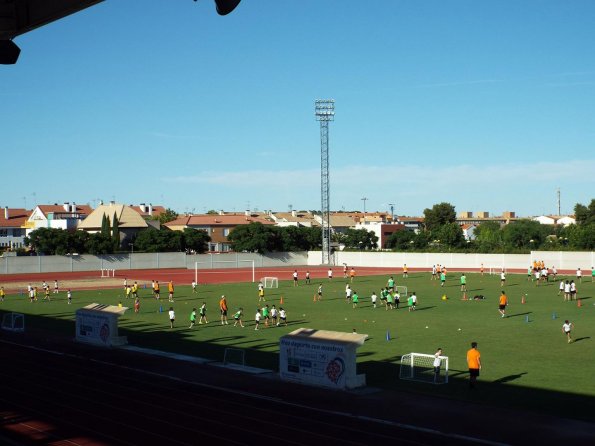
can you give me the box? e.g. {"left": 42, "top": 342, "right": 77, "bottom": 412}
{"left": 314, "top": 99, "right": 335, "bottom": 265}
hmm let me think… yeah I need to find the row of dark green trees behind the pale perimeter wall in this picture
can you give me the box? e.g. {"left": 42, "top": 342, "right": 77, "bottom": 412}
{"left": 25, "top": 199, "right": 595, "bottom": 255}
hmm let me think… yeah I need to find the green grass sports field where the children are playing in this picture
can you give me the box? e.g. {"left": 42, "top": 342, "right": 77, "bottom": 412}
{"left": 0, "top": 273, "right": 595, "bottom": 420}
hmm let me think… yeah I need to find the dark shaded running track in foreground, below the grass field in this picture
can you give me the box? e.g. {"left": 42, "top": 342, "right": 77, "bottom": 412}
{"left": 0, "top": 332, "right": 595, "bottom": 445}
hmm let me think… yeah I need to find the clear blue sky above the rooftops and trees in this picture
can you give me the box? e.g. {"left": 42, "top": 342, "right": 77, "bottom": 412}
{"left": 0, "top": 0, "right": 595, "bottom": 216}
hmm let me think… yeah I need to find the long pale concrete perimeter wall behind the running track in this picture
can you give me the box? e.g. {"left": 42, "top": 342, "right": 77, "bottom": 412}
{"left": 0, "top": 251, "right": 595, "bottom": 274}
